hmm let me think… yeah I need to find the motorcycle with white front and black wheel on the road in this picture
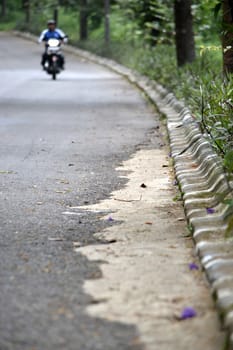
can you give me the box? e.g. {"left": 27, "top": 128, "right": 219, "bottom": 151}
{"left": 45, "top": 39, "right": 63, "bottom": 80}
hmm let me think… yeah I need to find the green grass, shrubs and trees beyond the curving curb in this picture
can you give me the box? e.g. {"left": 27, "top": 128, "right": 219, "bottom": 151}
{"left": 0, "top": 0, "right": 233, "bottom": 173}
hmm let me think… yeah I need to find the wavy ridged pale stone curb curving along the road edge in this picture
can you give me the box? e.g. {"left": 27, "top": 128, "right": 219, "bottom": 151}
{"left": 14, "top": 32, "right": 233, "bottom": 350}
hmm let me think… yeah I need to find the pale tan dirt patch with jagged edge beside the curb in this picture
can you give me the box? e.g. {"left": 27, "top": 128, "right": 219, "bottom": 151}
{"left": 75, "top": 150, "right": 224, "bottom": 350}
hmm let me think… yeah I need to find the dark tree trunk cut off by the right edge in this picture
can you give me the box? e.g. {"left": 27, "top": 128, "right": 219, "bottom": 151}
{"left": 222, "top": 0, "right": 233, "bottom": 73}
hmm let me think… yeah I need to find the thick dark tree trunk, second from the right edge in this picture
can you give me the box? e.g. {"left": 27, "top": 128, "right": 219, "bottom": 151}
{"left": 174, "top": 0, "right": 195, "bottom": 66}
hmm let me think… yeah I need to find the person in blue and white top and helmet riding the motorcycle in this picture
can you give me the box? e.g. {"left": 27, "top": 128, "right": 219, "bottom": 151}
{"left": 38, "top": 19, "right": 68, "bottom": 69}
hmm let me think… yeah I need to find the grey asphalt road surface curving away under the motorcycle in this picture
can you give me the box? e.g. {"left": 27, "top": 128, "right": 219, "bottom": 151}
{"left": 0, "top": 34, "right": 160, "bottom": 350}
